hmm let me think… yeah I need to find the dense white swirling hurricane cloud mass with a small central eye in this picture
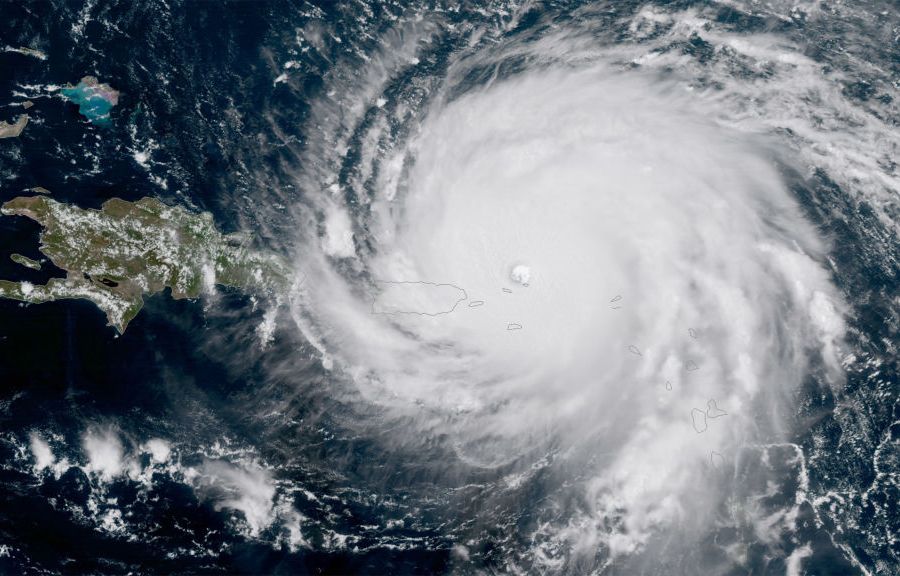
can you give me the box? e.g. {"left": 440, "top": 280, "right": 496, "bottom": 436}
{"left": 284, "top": 24, "right": 843, "bottom": 567}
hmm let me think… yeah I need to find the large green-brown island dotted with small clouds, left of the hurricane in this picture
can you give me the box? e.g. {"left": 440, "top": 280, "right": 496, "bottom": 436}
{"left": 0, "top": 196, "right": 290, "bottom": 333}
